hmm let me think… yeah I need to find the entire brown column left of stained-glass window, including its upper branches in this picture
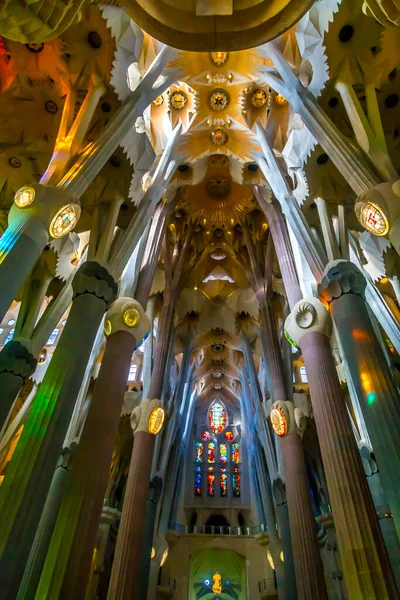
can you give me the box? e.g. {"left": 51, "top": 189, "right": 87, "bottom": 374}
{"left": 107, "top": 229, "right": 191, "bottom": 600}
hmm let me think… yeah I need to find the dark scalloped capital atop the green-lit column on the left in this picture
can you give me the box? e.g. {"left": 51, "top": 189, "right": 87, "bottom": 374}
{"left": 72, "top": 261, "right": 118, "bottom": 307}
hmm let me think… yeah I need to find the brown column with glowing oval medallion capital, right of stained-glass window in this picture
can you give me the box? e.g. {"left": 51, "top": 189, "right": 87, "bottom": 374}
{"left": 271, "top": 400, "right": 328, "bottom": 600}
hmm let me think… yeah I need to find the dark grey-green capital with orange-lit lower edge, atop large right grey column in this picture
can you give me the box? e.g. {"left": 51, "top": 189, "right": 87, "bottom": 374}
{"left": 318, "top": 259, "right": 367, "bottom": 307}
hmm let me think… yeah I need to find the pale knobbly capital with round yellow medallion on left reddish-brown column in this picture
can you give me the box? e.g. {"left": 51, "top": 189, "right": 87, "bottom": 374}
{"left": 104, "top": 298, "right": 151, "bottom": 347}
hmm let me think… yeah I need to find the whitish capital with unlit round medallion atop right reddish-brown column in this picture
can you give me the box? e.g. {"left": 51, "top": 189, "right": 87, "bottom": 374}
{"left": 285, "top": 297, "right": 332, "bottom": 347}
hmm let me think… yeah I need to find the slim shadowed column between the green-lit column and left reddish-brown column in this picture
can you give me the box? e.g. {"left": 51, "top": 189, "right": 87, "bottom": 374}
{"left": 17, "top": 443, "right": 76, "bottom": 600}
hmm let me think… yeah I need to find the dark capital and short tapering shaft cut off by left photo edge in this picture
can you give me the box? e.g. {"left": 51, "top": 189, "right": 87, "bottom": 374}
{"left": 0, "top": 338, "right": 37, "bottom": 429}
